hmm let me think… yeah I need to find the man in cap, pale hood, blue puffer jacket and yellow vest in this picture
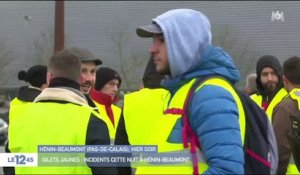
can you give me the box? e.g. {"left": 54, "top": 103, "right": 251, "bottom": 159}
{"left": 137, "top": 9, "right": 244, "bottom": 174}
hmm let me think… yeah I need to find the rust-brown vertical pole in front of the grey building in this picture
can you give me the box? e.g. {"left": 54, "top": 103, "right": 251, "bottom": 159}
{"left": 54, "top": 0, "right": 65, "bottom": 52}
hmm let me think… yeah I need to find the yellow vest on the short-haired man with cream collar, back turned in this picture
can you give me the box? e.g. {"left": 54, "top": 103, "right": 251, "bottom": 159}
{"left": 8, "top": 102, "right": 101, "bottom": 174}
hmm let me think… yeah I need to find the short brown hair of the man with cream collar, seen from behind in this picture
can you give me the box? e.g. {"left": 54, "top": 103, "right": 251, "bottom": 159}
{"left": 48, "top": 49, "right": 81, "bottom": 82}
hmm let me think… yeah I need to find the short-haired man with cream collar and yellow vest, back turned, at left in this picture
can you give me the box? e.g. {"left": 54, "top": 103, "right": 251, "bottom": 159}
{"left": 9, "top": 49, "right": 116, "bottom": 174}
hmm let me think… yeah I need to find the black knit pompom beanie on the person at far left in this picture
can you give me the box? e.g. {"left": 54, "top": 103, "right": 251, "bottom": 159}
{"left": 18, "top": 65, "right": 47, "bottom": 88}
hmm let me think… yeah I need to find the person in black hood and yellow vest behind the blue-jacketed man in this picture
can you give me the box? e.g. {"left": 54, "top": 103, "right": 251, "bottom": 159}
{"left": 117, "top": 58, "right": 170, "bottom": 145}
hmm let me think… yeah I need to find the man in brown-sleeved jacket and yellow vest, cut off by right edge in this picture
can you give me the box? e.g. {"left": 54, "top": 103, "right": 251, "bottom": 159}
{"left": 272, "top": 56, "right": 300, "bottom": 174}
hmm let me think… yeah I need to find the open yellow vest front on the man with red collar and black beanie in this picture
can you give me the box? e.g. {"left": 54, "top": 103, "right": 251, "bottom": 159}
{"left": 94, "top": 101, "right": 121, "bottom": 145}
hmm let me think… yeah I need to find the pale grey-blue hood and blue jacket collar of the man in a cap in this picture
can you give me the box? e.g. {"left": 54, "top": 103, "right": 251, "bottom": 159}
{"left": 153, "top": 9, "right": 240, "bottom": 93}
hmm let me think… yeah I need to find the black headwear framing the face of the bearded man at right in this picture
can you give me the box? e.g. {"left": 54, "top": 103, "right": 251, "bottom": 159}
{"left": 256, "top": 55, "right": 283, "bottom": 91}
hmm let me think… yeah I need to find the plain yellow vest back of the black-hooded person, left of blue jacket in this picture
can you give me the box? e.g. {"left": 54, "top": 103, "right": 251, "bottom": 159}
{"left": 123, "top": 88, "right": 170, "bottom": 145}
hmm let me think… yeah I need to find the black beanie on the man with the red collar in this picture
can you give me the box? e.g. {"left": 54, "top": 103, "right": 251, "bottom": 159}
{"left": 95, "top": 67, "right": 121, "bottom": 91}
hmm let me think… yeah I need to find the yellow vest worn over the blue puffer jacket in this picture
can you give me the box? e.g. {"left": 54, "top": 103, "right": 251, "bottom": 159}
{"left": 124, "top": 78, "right": 245, "bottom": 174}
